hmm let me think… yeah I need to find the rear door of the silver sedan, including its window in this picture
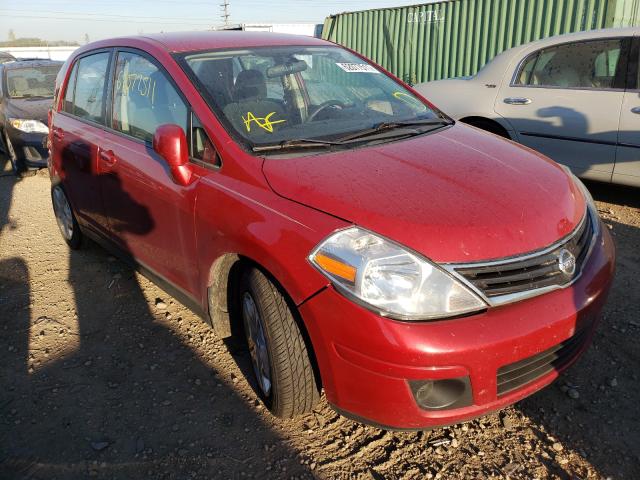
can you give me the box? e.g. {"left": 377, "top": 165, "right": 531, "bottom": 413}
{"left": 495, "top": 38, "right": 630, "bottom": 181}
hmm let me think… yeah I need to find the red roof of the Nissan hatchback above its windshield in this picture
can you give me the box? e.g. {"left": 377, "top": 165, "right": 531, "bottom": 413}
{"left": 82, "top": 31, "right": 333, "bottom": 53}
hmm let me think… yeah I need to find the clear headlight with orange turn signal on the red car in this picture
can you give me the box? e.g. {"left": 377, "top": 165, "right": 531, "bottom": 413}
{"left": 309, "top": 227, "right": 487, "bottom": 320}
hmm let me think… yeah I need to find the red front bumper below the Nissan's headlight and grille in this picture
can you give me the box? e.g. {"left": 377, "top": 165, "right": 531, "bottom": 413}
{"left": 300, "top": 225, "right": 615, "bottom": 429}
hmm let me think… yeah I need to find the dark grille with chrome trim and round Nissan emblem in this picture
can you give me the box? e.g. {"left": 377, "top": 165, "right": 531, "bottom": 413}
{"left": 453, "top": 213, "right": 594, "bottom": 299}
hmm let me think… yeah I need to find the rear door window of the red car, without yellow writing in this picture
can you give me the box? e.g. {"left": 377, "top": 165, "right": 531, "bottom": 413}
{"left": 71, "top": 52, "right": 110, "bottom": 125}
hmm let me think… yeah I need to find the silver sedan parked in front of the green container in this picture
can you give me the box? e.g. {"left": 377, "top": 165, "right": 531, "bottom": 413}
{"left": 416, "top": 28, "right": 640, "bottom": 186}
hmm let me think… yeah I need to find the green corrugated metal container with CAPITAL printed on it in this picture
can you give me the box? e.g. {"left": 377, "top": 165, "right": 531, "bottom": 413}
{"left": 322, "top": 0, "right": 640, "bottom": 84}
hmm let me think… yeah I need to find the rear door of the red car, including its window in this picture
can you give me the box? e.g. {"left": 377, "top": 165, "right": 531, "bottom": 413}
{"left": 51, "top": 50, "right": 112, "bottom": 234}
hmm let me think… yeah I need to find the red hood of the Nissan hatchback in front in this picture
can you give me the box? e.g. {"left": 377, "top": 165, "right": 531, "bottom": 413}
{"left": 263, "top": 124, "right": 585, "bottom": 262}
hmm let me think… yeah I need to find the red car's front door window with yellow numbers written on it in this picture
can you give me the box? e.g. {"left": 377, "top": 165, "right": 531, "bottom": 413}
{"left": 112, "top": 52, "right": 188, "bottom": 142}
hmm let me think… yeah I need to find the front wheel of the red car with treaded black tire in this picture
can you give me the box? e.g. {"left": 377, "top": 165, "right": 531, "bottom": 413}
{"left": 239, "top": 268, "right": 320, "bottom": 418}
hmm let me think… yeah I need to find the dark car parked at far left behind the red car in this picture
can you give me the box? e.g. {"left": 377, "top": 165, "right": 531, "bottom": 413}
{"left": 0, "top": 60, "right": 63, "bottom": 174}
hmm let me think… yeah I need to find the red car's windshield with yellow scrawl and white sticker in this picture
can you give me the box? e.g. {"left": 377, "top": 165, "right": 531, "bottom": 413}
{"left": 184, "top": 46, "right": 442, "bottom": 150}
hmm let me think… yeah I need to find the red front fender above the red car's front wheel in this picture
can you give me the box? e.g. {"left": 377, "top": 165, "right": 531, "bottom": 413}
{"left": 195, "top": 175, "right": 348, "bottom": 307}
